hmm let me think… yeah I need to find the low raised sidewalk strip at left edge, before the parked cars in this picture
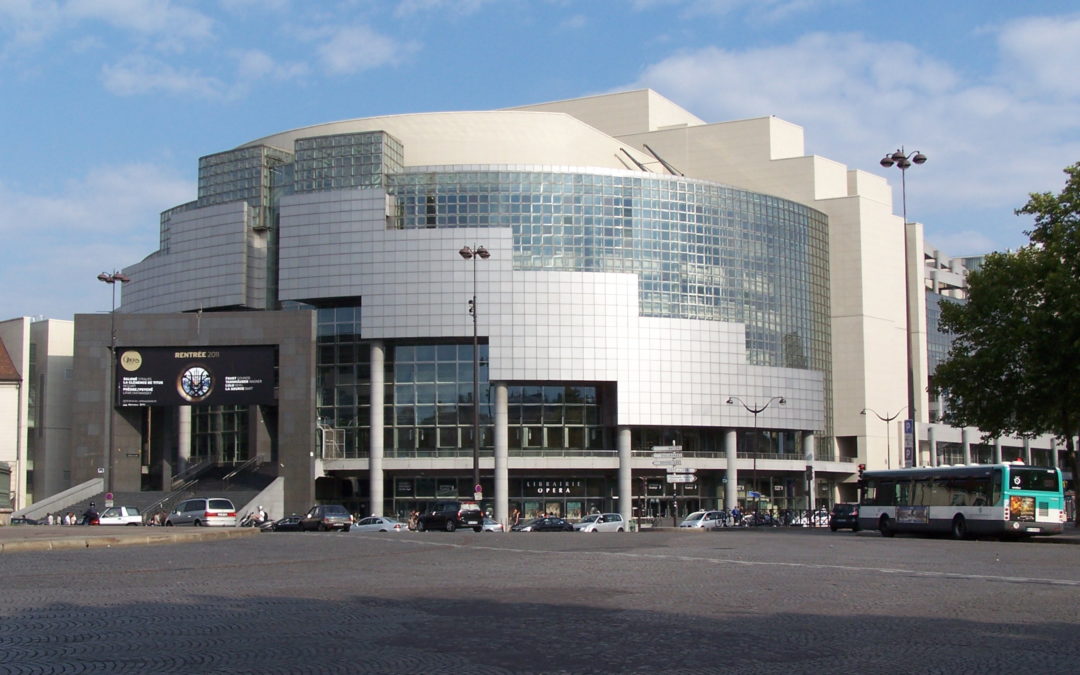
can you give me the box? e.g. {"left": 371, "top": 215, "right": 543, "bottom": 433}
{"left": 0, "top": 525, "right": 259, "bottom": 553}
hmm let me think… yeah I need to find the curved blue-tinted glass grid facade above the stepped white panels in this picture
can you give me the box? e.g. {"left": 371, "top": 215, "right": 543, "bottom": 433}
{"left": 387, "top": 167, "right": 829, "bottom": 373}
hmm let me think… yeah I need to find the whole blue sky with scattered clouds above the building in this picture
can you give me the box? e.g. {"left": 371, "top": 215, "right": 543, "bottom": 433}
{"left": 0, "top": 0, "right": 1080, "bottom": 320}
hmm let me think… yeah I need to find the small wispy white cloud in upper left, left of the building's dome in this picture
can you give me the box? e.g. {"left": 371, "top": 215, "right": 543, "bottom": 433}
{"left": 102, "top": 54, "right": 227, "bottom": 98}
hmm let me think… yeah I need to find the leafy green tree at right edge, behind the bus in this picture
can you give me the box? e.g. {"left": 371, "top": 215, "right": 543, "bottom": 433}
{"left": 931, "top": 158, "right": 1080, "bottom": 523}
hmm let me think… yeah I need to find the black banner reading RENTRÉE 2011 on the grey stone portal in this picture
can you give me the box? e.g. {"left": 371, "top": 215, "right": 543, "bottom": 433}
{"left": 117, "top": 347, "right": 274, "bottom": 407}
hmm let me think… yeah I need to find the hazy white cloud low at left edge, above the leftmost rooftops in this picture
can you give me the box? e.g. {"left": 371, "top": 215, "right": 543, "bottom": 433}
{"left": 0, "top": 164, "right": 195, "bottom": 319}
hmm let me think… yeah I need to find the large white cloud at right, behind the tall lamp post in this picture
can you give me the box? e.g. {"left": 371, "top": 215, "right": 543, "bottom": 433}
{"left": 631, "top": 22, "right": 1080, "bottom": 252}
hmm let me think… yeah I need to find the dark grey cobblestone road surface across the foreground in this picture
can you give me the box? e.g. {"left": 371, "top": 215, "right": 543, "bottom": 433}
{"left": 0, "top": 530, "right": 1080, "bottom": 674}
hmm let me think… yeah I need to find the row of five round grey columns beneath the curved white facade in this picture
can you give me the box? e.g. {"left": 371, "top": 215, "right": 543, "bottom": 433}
{"left": 368, "top": 341, "right": 815, "bottom": 524}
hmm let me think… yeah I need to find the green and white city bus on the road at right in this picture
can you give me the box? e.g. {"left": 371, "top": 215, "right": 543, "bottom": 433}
{"left": 859, "top": 462, "right": 1065, "bottom": 539}
